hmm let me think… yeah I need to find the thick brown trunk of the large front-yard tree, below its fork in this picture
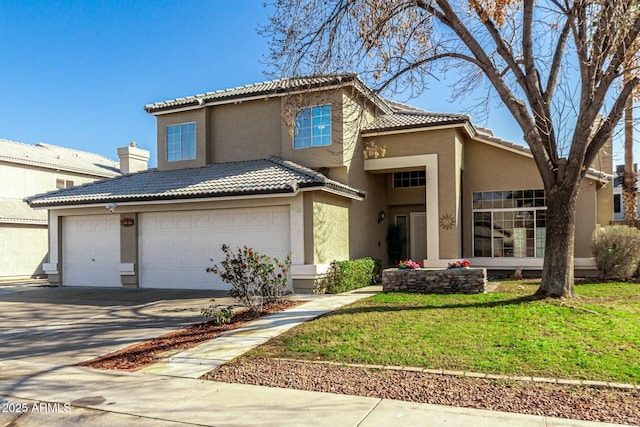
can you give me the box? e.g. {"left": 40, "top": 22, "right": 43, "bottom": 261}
{"left": 536, "top": 189, "right": 580, "bottom": 298}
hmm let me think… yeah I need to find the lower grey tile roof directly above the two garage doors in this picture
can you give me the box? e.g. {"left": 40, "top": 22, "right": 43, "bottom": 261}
{"left": 27, "top": 157, "right": 364, "bottom": 207}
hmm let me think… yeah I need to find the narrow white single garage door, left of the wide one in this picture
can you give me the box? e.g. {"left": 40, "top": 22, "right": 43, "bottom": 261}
{"left": 62, "top": 215, "right": 122, "bottom": 286}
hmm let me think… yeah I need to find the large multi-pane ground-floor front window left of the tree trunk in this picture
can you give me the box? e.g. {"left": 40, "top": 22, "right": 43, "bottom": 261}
{"left": 473, "top": 190, "right": 547, "bottom": 258}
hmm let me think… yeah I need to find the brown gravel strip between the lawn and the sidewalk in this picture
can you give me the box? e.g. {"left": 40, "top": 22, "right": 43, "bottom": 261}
{"left": 202, "top": 358, "right": 640, "bottom": 425}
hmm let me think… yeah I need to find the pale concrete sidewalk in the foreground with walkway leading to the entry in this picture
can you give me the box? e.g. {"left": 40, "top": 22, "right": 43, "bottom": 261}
{"left": 0, "top": 289, "right": 632, "bottom": 427}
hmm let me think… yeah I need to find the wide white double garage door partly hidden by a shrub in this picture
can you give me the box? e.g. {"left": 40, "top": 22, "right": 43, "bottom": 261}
{"left": 140, "top": 206, "right": 290, "bottom": 289}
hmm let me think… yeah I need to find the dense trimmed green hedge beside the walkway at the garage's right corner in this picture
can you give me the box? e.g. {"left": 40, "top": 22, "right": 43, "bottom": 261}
{"left": 316, "top": 258, "right": 376, "bottom": 294}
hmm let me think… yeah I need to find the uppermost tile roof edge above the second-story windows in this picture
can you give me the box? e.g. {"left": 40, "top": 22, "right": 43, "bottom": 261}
{"left": 144, "top": 73, "right": 391, "bottom": 114}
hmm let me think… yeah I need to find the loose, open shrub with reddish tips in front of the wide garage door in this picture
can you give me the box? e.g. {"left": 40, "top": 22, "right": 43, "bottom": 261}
{"left": 207, "top": 245, "right": 291, "bottom": 313}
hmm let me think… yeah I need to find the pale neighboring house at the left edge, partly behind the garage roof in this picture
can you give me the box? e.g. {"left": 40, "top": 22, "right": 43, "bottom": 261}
{"left": 0, "top": 139, "right": 148, "bottom": 279}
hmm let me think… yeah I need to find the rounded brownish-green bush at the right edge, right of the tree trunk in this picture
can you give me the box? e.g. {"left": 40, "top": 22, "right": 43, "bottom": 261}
{"left": 591, "top": 225, "right": 640, "bottom": 279}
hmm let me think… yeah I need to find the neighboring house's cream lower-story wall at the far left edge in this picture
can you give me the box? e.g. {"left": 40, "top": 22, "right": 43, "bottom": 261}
{"left": 0, "top": 224, "right": 47, "bottom": 278}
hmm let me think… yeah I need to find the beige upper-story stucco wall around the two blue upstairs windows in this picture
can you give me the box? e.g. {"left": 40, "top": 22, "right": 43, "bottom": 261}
{"left": 157, "top": 87, "right": 372, "bottom": 170}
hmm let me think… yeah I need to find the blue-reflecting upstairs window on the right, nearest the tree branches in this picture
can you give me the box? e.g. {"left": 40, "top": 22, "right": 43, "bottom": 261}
{"left": 293, "top": 105, "right": 331, "bottom": 148}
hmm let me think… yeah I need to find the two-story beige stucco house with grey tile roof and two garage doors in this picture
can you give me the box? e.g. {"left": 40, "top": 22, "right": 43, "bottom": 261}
{"left": 29, "top": 74, "right": 613, "bottom": 291}
